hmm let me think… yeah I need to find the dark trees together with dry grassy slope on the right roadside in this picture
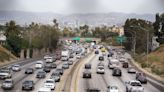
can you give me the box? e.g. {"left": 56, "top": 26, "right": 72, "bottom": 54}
{"left": 124, "top": 13, "right": 164, "bottom": 78}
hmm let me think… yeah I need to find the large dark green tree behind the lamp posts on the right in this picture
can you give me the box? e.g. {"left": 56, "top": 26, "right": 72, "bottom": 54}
{"left": 124, "top": 19, "right": 154, "bottom": 53}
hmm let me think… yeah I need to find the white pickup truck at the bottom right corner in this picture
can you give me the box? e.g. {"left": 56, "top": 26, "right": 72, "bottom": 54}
{"left": 125, "top": 80, "right": 144, "bottom": 92}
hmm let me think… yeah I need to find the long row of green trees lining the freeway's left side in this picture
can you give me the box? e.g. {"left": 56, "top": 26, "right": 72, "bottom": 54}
{"left": 0, "top": 19, "right": 61, "bottom": 61}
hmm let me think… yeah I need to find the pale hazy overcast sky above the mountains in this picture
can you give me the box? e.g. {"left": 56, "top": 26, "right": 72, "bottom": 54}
{"left": 0, "top": 0, "right": 164, "bottom": 14}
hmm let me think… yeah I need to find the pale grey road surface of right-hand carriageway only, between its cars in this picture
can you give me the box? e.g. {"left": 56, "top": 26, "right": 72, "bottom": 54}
{"left": 71, "top": 49, "right": 162, "bottom": 92}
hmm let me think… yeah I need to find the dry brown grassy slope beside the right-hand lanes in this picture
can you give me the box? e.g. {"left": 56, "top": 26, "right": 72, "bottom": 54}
{"left": 137, "top": 44, "right": 164, "bottom": 78}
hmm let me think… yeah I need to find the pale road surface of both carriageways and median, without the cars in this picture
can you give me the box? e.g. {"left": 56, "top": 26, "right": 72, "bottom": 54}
{"left": 0, "top": 44, "right": 163, "bottom": 92}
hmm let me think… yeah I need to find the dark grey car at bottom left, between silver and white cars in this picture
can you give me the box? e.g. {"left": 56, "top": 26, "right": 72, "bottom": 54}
{"left": 22, "top": 80, "right": 34, "bottom": 90}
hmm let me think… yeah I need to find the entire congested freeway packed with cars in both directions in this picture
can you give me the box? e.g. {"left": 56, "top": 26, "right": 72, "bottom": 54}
{"left": 0, "top": 43, "right": 162, "bottom": 92}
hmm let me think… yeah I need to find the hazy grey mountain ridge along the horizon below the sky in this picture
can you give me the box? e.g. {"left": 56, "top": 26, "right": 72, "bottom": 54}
{"left": 0, "top": 11, "right": 155, "bottom": 27}
